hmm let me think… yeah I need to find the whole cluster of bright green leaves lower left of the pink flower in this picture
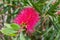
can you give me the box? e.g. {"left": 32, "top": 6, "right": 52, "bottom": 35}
{"left": 0, "top": 23, "right": 20, "bottom": 36}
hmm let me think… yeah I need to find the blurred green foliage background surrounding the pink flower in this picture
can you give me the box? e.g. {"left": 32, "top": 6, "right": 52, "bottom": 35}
{"left": 0, "top": 0, "right": 60, "bottom": 40}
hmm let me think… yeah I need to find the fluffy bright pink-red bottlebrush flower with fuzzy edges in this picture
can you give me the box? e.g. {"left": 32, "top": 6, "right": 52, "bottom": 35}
{"left": 14, "top": 7, "right": 40, "bottom": 33}
